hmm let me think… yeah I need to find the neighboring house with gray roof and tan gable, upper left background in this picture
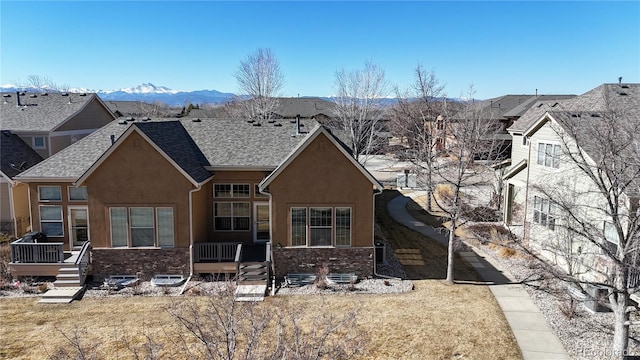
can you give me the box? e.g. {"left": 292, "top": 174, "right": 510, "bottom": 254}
{"left": 0, "top": 92, "right": 115, "bottom": 158}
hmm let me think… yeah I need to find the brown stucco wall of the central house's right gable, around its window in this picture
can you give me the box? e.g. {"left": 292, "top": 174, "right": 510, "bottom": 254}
{"left": 269, "top": 134, "right": 374, "bottom": 247}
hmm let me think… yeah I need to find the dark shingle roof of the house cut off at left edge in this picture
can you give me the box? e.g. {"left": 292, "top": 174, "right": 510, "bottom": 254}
{"left": 0, "top": 130, "right": 42, "bottom": 179}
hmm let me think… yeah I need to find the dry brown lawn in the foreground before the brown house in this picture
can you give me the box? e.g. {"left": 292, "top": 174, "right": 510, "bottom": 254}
{"left": 0, "top": 280, "right": 520, "bottom": 359}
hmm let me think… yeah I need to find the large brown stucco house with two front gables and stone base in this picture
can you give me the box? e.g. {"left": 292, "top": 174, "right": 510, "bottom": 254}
{"left": 12, "top": 118, "right": 381, "bottom": 284}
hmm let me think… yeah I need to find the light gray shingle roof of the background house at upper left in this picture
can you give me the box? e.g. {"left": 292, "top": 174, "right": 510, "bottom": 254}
{"left": 0, "top": 92, "right": 102, "bottom": 131}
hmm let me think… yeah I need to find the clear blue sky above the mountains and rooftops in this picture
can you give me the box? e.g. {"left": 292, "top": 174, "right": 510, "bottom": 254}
{"left": 0, "top": 0, "right": 640, "bottom": 98}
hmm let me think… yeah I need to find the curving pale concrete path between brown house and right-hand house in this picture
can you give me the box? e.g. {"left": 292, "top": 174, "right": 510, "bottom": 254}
{"left": 387, "top": 196, "right": 569, "bottom": 360}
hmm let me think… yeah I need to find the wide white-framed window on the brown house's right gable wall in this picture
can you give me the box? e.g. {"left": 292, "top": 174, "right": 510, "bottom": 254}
{"left": 290, "top": 207, "right": 352, "bottom": 246}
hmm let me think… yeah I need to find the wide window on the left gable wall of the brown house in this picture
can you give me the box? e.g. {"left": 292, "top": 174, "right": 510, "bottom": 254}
{"left": 109, "top": 207, "right": 175, "bottom": 247}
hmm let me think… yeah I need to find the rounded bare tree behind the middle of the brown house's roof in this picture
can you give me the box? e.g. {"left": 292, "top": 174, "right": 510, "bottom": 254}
{"left": 234, "top": 48, "right": 285, "bottom": 119}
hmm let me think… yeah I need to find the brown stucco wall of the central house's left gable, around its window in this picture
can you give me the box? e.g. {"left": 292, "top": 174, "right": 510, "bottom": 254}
{"left": 85, "top": 132, "right": 195, "bottom": 248}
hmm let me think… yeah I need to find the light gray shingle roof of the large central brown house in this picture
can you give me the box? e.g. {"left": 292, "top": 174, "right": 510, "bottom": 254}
{"left": 20, "top": 118, "right": 319, "bottom": 181}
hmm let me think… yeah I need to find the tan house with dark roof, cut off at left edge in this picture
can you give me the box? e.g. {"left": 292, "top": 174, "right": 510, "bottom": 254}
{"left": 0, "top": 130, "right": 42, "bottom": 236}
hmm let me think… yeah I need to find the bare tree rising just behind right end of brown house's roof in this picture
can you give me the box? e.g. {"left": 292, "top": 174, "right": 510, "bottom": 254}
{"left": 333, "top": 62, "right": 389, "bottom": 164}
